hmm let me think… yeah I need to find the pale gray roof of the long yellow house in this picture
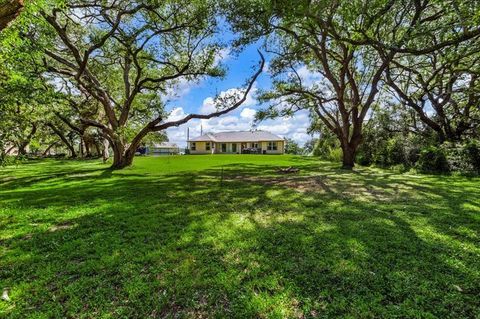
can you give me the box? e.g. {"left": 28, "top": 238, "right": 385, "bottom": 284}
{"left": 189, "top": 131, "right": 283, "bottom": 143}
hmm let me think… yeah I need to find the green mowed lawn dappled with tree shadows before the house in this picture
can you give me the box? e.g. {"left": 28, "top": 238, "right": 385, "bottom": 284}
{"left": 0, "top": 155, "right": 480, "bottom": 318}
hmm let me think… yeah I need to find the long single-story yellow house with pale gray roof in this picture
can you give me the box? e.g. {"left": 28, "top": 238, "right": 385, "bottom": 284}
{"left": 187, "top": 131, "right": 285, "bottom": 154}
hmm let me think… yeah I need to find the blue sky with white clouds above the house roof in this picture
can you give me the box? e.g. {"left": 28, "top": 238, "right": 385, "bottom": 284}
{"left": 163, "top": 45, "right": 311, "bottom": 147}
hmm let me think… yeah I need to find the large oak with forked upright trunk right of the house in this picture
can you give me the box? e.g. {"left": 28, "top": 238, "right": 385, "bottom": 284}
{"left": 226, "top": 0, "right": 480, "bottom": 168}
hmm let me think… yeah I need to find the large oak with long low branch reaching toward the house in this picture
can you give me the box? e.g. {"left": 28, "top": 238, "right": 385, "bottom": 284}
{"left": 29, "top": 0, "right": 263, "bottom": 169}
